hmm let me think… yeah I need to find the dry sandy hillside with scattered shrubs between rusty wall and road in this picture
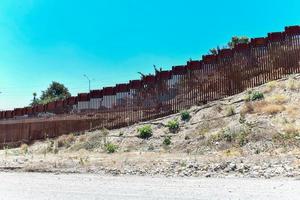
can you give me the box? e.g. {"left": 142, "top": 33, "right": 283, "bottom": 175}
{"left": 0, "top": 75, "right": 300, "bottom": 178}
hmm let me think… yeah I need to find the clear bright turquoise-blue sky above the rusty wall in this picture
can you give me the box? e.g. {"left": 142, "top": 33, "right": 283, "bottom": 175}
{"left": 0, "top": 0, "right": 300, "bottom": 109}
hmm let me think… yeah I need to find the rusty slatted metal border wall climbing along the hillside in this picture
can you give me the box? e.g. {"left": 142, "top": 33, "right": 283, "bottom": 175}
{"left": 0, "top": 26, "right": 300, "bottom": 147}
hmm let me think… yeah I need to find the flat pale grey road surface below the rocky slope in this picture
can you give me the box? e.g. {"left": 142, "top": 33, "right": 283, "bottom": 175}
{"left": 0, "top": 173, "right": 300, "bottom": 200}
